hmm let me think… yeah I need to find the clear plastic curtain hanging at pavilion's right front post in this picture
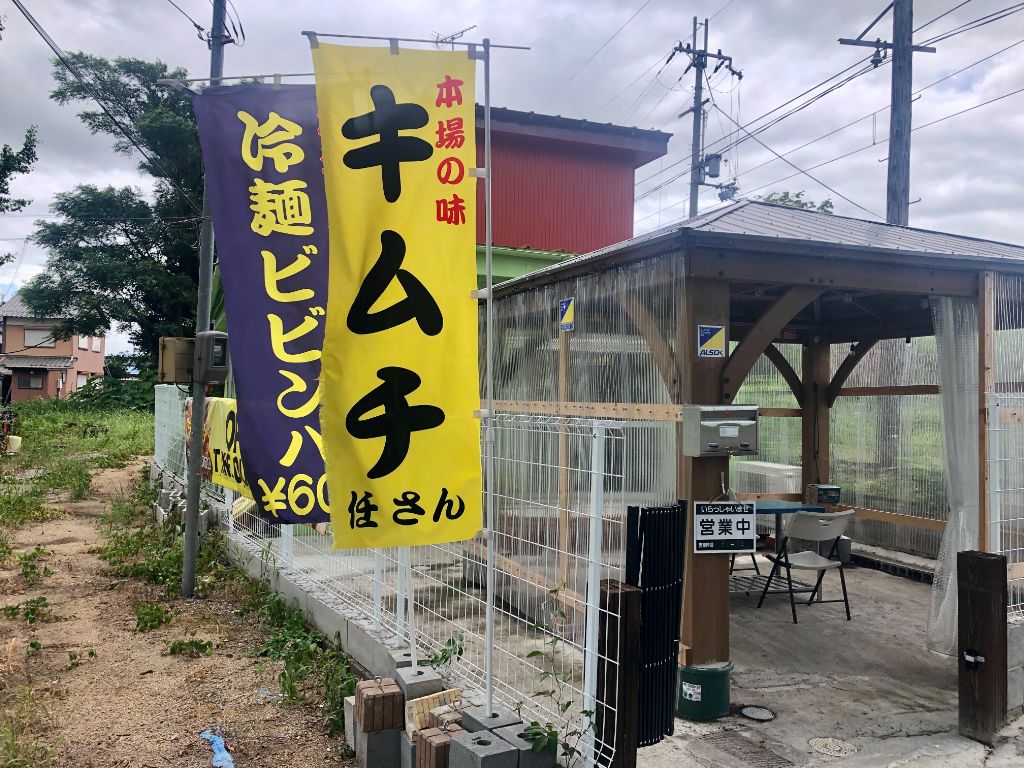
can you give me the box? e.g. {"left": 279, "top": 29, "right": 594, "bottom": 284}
{"left": 928, "top": 297, "right": 979, "bottom": 654}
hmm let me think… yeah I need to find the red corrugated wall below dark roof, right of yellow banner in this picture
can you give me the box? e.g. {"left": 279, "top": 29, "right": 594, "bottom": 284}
{"left": 476, "top": 131, "right": 634, "bottom": 253}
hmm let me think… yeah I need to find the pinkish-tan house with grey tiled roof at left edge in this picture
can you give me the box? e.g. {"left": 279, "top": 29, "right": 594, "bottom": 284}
{"left": 0, "top": 294, "right": 106, "bottom": 402}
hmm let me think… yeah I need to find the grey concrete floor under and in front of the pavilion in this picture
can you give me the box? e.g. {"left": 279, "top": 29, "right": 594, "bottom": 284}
{"left": 639, "top": 568, "right": 1024, "bottom": 768}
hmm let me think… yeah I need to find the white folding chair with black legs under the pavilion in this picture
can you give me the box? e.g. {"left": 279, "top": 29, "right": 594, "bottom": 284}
{"left": 758, "top": 509, "right": 853, "bottom": 624}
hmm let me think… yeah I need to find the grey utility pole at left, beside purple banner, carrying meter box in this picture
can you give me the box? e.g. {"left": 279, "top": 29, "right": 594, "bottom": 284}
{"left": 181, "top": 0, "right": 230, "bottom": 597}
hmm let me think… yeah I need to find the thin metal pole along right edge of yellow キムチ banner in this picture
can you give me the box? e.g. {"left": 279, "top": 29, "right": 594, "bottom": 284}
{"left": 483, "top": 38, "right": 495, "bottom": 718}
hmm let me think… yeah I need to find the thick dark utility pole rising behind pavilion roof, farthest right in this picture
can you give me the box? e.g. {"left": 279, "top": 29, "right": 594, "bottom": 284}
{"left": 839, "top": 0, "right": 935, "bottom": 226}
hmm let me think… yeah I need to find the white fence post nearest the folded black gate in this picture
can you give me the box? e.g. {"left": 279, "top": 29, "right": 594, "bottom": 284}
{"left": 583, "top": 422, "right": 604, "bottom": 768}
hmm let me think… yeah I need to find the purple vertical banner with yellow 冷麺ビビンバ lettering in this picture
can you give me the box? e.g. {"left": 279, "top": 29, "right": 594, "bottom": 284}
{"left": 193, "top": 85, "right": 329, "bottom": 523}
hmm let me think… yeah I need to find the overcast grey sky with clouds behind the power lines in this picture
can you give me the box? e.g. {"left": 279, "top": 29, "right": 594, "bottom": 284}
{"left": 0, "top": 0, "right": 1024, "bottom": 351}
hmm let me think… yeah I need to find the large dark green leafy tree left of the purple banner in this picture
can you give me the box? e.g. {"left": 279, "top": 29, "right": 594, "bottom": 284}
{"left": 22, "top": 52, "right": 203, "bottom": 360}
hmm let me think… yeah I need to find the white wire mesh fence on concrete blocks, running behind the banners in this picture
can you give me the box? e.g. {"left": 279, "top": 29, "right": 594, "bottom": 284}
{"left": 155, "top": 387, "right": 638, "bottom": 765}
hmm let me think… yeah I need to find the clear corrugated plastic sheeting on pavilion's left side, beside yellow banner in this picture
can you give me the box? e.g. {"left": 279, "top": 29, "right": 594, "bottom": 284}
{"left": 489, "top": 254, "right": 684, "bottom": 514}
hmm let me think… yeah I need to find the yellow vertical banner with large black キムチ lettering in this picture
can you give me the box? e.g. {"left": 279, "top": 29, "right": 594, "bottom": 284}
{"left": 312, "top": 45, "right": 481, "bottom": 548}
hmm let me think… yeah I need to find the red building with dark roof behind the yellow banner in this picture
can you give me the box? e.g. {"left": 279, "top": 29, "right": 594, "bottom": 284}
{"left": 476, "top": 104, "right": 671, "bottom": 257}
